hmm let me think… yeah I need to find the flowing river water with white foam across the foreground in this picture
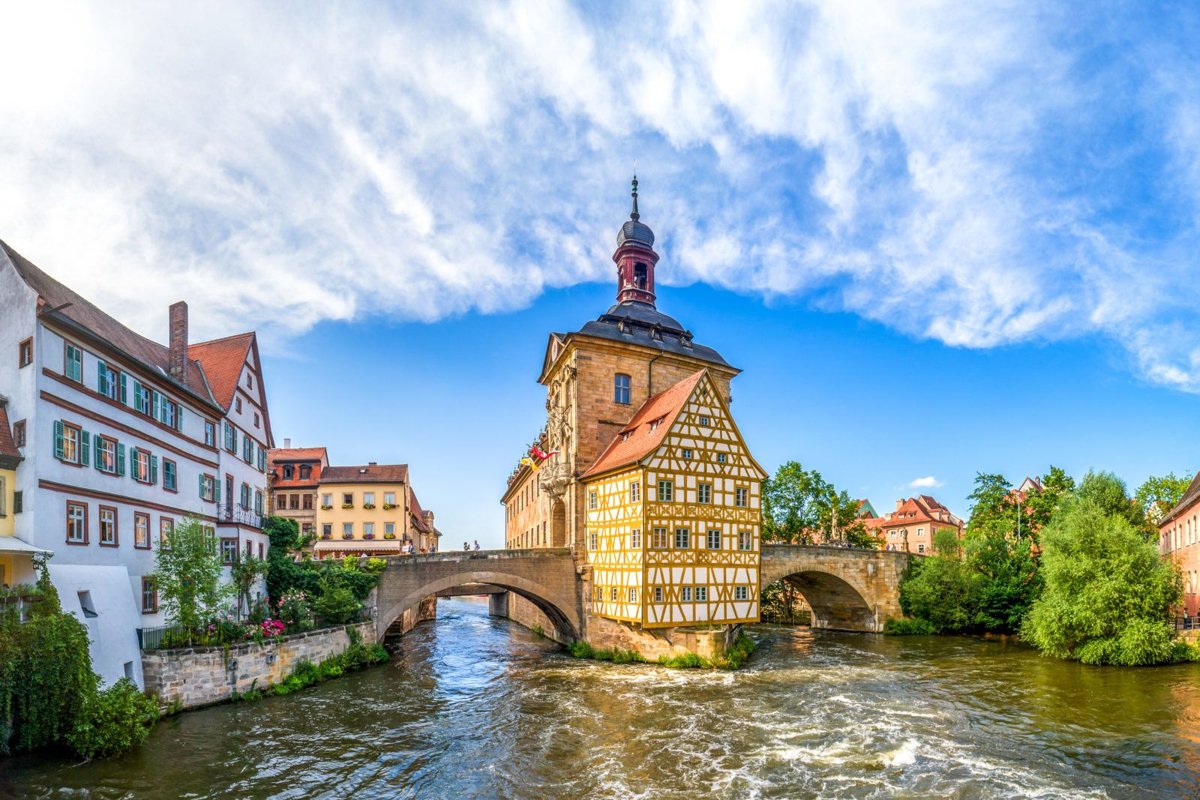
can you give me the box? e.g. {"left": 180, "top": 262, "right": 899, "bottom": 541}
{"left": 0, "top": 599, "right": 1200, "bottom": 799}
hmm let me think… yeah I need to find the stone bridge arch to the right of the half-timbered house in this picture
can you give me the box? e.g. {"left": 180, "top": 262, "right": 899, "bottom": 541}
{"left": 762, "top": 545, "right": 912, "bottom": 633}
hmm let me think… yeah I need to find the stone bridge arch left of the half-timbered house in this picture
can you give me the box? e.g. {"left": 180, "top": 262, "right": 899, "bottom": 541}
{"left": 376, "top": 549, "right": 583, "bottom": 642}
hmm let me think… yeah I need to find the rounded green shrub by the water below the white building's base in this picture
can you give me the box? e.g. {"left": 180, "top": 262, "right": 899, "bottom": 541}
{"left": 66, "top": 678, "right": 158, "bottom": 760}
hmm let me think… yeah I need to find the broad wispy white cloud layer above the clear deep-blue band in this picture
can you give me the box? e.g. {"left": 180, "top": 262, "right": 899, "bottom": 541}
{"left": 0, "top": 1, "right": 1200, "bottom": 391}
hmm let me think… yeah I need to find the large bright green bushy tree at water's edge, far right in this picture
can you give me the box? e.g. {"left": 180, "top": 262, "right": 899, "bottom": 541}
{"left": 1021, "top": 501, "right": 1182, "bottom": 666}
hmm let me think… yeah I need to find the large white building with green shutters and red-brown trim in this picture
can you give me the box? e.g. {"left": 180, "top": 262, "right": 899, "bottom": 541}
{"left": 0, "top": 241, "right": 272, "bottom": 685}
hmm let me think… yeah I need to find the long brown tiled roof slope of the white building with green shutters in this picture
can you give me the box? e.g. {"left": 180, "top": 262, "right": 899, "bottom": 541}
{"left": 0, "top": 241, "right": 215, "bottom": 404}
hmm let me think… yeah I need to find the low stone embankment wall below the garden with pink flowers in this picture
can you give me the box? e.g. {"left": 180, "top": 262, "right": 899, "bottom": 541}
{"left": 142, "top": 622, "right": 374, "bottom": 709}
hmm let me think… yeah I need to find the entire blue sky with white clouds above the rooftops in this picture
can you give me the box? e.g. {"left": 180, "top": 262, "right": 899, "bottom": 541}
{"left": 0, "top": 0, "right": 1200, "bottom": 545}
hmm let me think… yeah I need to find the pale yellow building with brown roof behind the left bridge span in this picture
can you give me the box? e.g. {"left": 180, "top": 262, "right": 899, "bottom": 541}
{"left": 313, "top": 462, "right": 439, "bottom": 558}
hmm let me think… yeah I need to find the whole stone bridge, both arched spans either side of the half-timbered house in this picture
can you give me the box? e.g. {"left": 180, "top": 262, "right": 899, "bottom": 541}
{"left": 376, "top": 545, "right": 910, "bottom": 642}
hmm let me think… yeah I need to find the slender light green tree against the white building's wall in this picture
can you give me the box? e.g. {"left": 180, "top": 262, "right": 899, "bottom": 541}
{"left": 154, "top": 519, "right": 229, "bottom": 640}
